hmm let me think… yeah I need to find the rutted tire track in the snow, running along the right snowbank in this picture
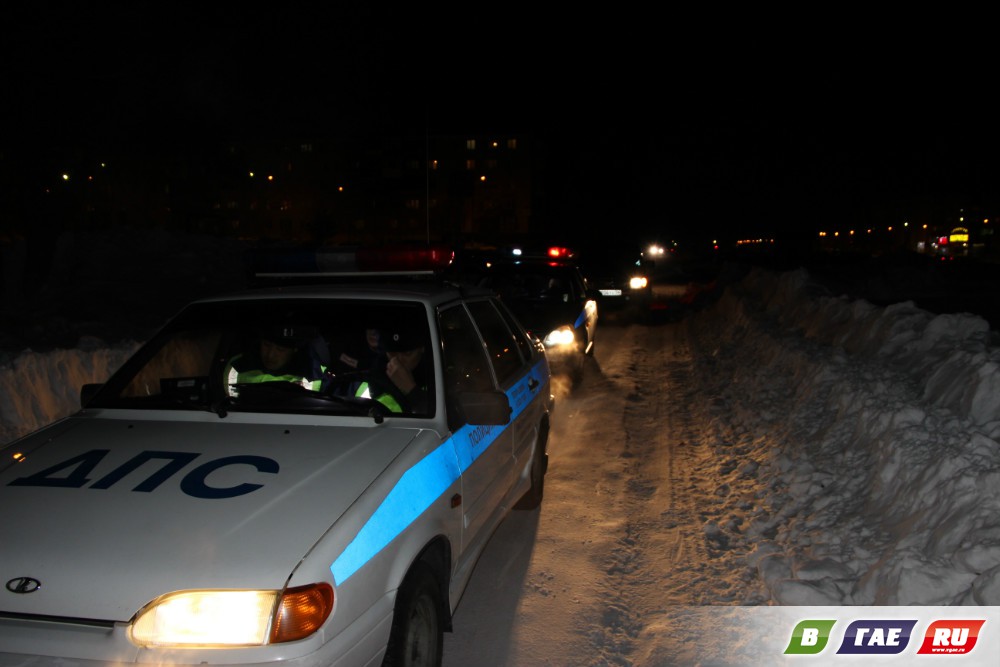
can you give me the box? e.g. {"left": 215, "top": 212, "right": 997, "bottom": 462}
{"left": 591, "top": 325, "right": 709, "bottom": 664}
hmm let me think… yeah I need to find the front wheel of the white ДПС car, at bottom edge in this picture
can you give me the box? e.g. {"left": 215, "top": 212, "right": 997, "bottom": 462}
{"left": 382, "top": 563, "right": 444, "bottom": 667}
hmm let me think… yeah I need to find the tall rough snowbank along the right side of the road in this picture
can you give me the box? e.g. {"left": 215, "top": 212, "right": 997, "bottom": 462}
{"left": 691, "top": 270, "right": 1000, "bottom": 605}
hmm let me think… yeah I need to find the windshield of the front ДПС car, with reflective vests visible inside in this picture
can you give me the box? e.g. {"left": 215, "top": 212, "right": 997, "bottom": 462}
{"left": 87, "top": 298, "right": 434, "bottom": 417}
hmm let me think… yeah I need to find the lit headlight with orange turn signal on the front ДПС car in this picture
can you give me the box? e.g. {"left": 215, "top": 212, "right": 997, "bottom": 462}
{"left": 130, "top": 584, "right": 333, "bottom": 648}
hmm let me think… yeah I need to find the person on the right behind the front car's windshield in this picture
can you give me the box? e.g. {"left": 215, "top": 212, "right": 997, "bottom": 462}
{"left": 355, "top": 327, "right": 431, "bottom": 414}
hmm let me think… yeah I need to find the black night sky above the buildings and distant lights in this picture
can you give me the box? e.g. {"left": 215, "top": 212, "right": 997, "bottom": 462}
{"left": 7, "top": 2, "right": 1000, "bottom": 247}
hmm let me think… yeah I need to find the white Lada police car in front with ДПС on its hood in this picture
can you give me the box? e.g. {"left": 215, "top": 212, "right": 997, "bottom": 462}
{"left": 0, "top": 249, "right": 554, "bottom": 666}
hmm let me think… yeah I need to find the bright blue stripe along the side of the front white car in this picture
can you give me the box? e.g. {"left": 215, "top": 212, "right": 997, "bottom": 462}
{"left": 330, "top": 361, "right": 545, "bottom": 585}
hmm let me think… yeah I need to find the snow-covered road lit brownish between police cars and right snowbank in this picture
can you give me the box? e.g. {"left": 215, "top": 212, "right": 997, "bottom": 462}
{"left": 445, "top": 323, "right": 752, "bottom": 667}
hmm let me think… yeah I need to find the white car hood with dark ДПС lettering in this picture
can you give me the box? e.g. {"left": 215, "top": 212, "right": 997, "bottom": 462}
{"left": 0, "top": 417, "right": 419, "bottom": 621}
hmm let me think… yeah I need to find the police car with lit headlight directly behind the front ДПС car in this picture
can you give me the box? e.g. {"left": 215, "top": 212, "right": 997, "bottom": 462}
{"left": 458, "top": 248, "right": 598, "bottom": 381}
